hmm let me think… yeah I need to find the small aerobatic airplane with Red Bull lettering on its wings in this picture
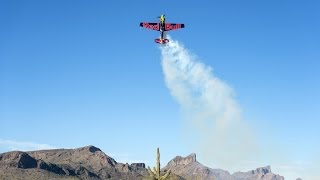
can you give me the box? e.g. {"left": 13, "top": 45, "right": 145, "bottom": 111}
{"left": 140, "top": 14, "right": 184, "bottom": 44}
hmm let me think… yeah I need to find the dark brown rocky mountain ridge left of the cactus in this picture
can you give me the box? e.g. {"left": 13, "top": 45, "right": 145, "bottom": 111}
{"left": 0, "top": 146, "right": 147, "bottom": 179}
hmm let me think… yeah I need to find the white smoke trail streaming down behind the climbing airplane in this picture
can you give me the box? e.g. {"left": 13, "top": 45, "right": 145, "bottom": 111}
{"left": 161, "top": 39, "right": 255, "bottom": 170}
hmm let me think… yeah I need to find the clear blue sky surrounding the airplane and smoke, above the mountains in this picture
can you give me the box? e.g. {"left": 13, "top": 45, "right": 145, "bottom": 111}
{"left": 0, "top": 0, "right": 320, "bottom": 179}
